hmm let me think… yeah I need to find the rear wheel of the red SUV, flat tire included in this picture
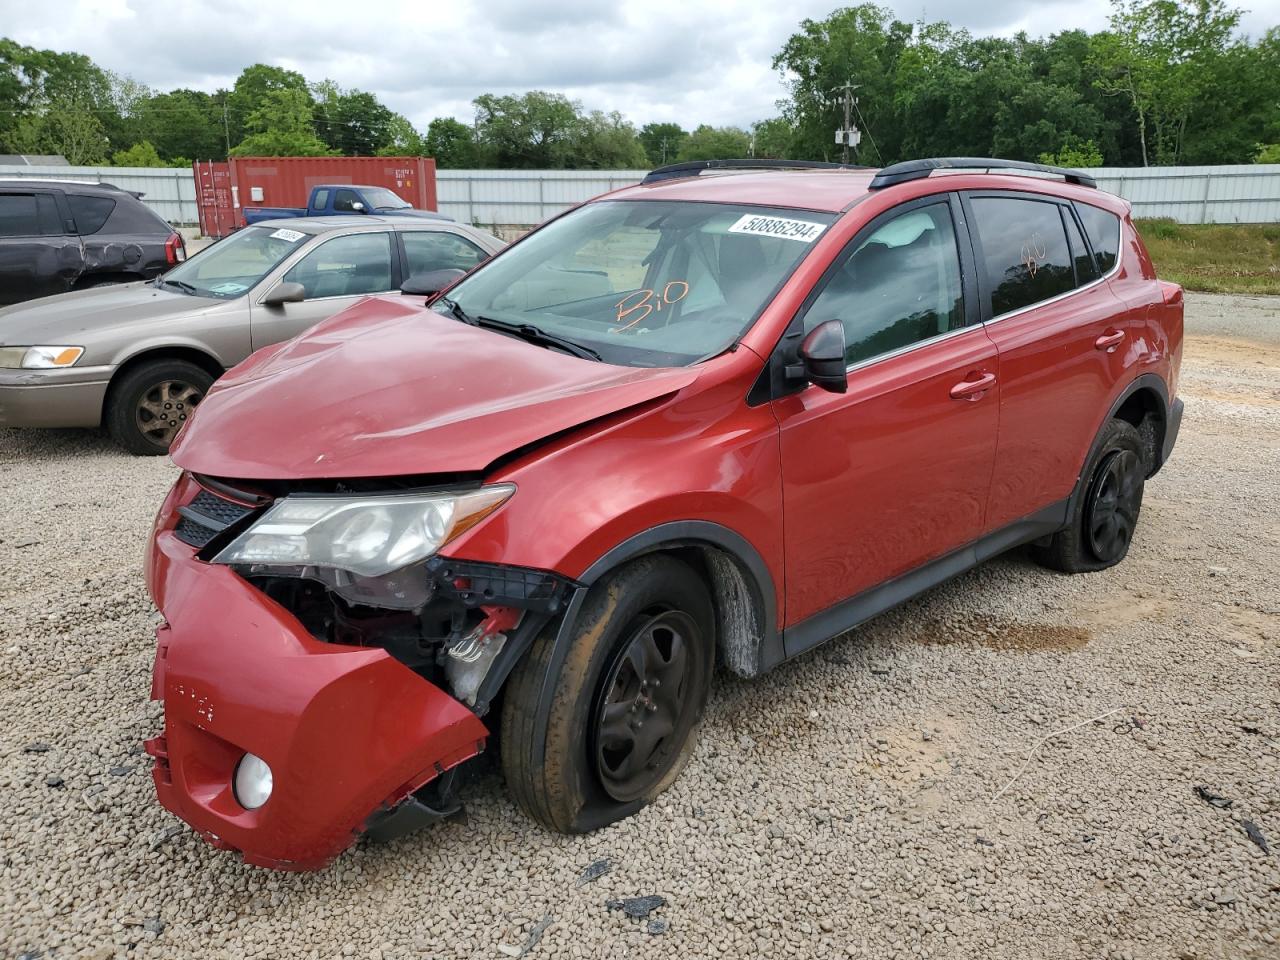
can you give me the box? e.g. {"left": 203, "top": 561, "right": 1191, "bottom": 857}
{"left": 1032, "top": 420, "right": 1148, "bottom": 573}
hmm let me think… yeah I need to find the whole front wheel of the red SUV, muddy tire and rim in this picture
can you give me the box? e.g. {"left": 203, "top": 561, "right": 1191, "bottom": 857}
{"left": 502, "top": 556, "right": 716, "bottom": 833}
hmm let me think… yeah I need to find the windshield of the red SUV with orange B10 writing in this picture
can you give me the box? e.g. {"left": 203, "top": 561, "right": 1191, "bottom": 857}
{"left": 433, "top": 200, "right": 835, "bottom": 366}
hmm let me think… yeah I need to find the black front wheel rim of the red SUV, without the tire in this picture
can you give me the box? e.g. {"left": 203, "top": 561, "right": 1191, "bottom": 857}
{"left": 595, "top": 609, "right": 700, "bottom": 803}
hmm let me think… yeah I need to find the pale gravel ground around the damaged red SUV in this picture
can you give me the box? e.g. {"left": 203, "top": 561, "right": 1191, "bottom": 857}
{"left": 0, "top": 296, "right": 1280, "bottom": 960}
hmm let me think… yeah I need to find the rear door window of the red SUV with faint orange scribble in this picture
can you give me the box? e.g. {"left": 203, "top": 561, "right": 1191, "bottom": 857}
{"left": 970, "top": 197, "right": 1075, "bottom": 316}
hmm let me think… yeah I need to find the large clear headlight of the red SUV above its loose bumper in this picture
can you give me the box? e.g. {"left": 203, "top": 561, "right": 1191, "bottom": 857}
{"left": 214, "top": 484, "right": 516, "bottom": 577}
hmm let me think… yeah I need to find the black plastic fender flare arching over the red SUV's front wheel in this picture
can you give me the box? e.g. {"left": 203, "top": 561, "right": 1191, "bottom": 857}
{"left": 522, "top": 520, "right": 783, "bottom": 763}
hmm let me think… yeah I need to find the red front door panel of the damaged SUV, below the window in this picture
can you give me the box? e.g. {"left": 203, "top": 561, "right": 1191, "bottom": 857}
{"left": 773, "top": 326, "right": 1000, "bottom": 623}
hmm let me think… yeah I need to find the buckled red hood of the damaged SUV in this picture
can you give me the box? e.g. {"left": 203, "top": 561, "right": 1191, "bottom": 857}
{"left": 172, "top": 298, "right": 698, "bottom": 480}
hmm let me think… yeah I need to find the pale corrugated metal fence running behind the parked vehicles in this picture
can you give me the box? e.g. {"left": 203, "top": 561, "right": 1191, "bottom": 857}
{"left": 0, "top": 164, "right": 1280, "bottom": 227}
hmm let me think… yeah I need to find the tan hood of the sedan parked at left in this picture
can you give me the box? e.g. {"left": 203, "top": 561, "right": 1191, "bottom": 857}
{"left": 0, "top": 282, "right": 227, "bottom": 347}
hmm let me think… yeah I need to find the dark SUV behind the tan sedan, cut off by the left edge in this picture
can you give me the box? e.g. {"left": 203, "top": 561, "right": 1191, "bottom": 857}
{"left": 0, "top": 179, "right": 187, "bottom": 303}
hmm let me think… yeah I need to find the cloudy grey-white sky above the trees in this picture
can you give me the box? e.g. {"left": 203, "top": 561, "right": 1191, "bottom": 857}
{"left": 0, "top": 0, "right": 1280, "bottom": 128}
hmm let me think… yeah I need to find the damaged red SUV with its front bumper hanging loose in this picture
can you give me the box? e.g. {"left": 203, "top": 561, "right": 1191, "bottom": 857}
{"left": 140, "top": 159, "right": 1183, "bottom": 869}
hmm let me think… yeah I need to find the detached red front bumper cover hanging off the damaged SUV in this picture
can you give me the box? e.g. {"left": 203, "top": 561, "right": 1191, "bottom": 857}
{"left": 146, "top": 519, "right": 488, "bottom": 870}
